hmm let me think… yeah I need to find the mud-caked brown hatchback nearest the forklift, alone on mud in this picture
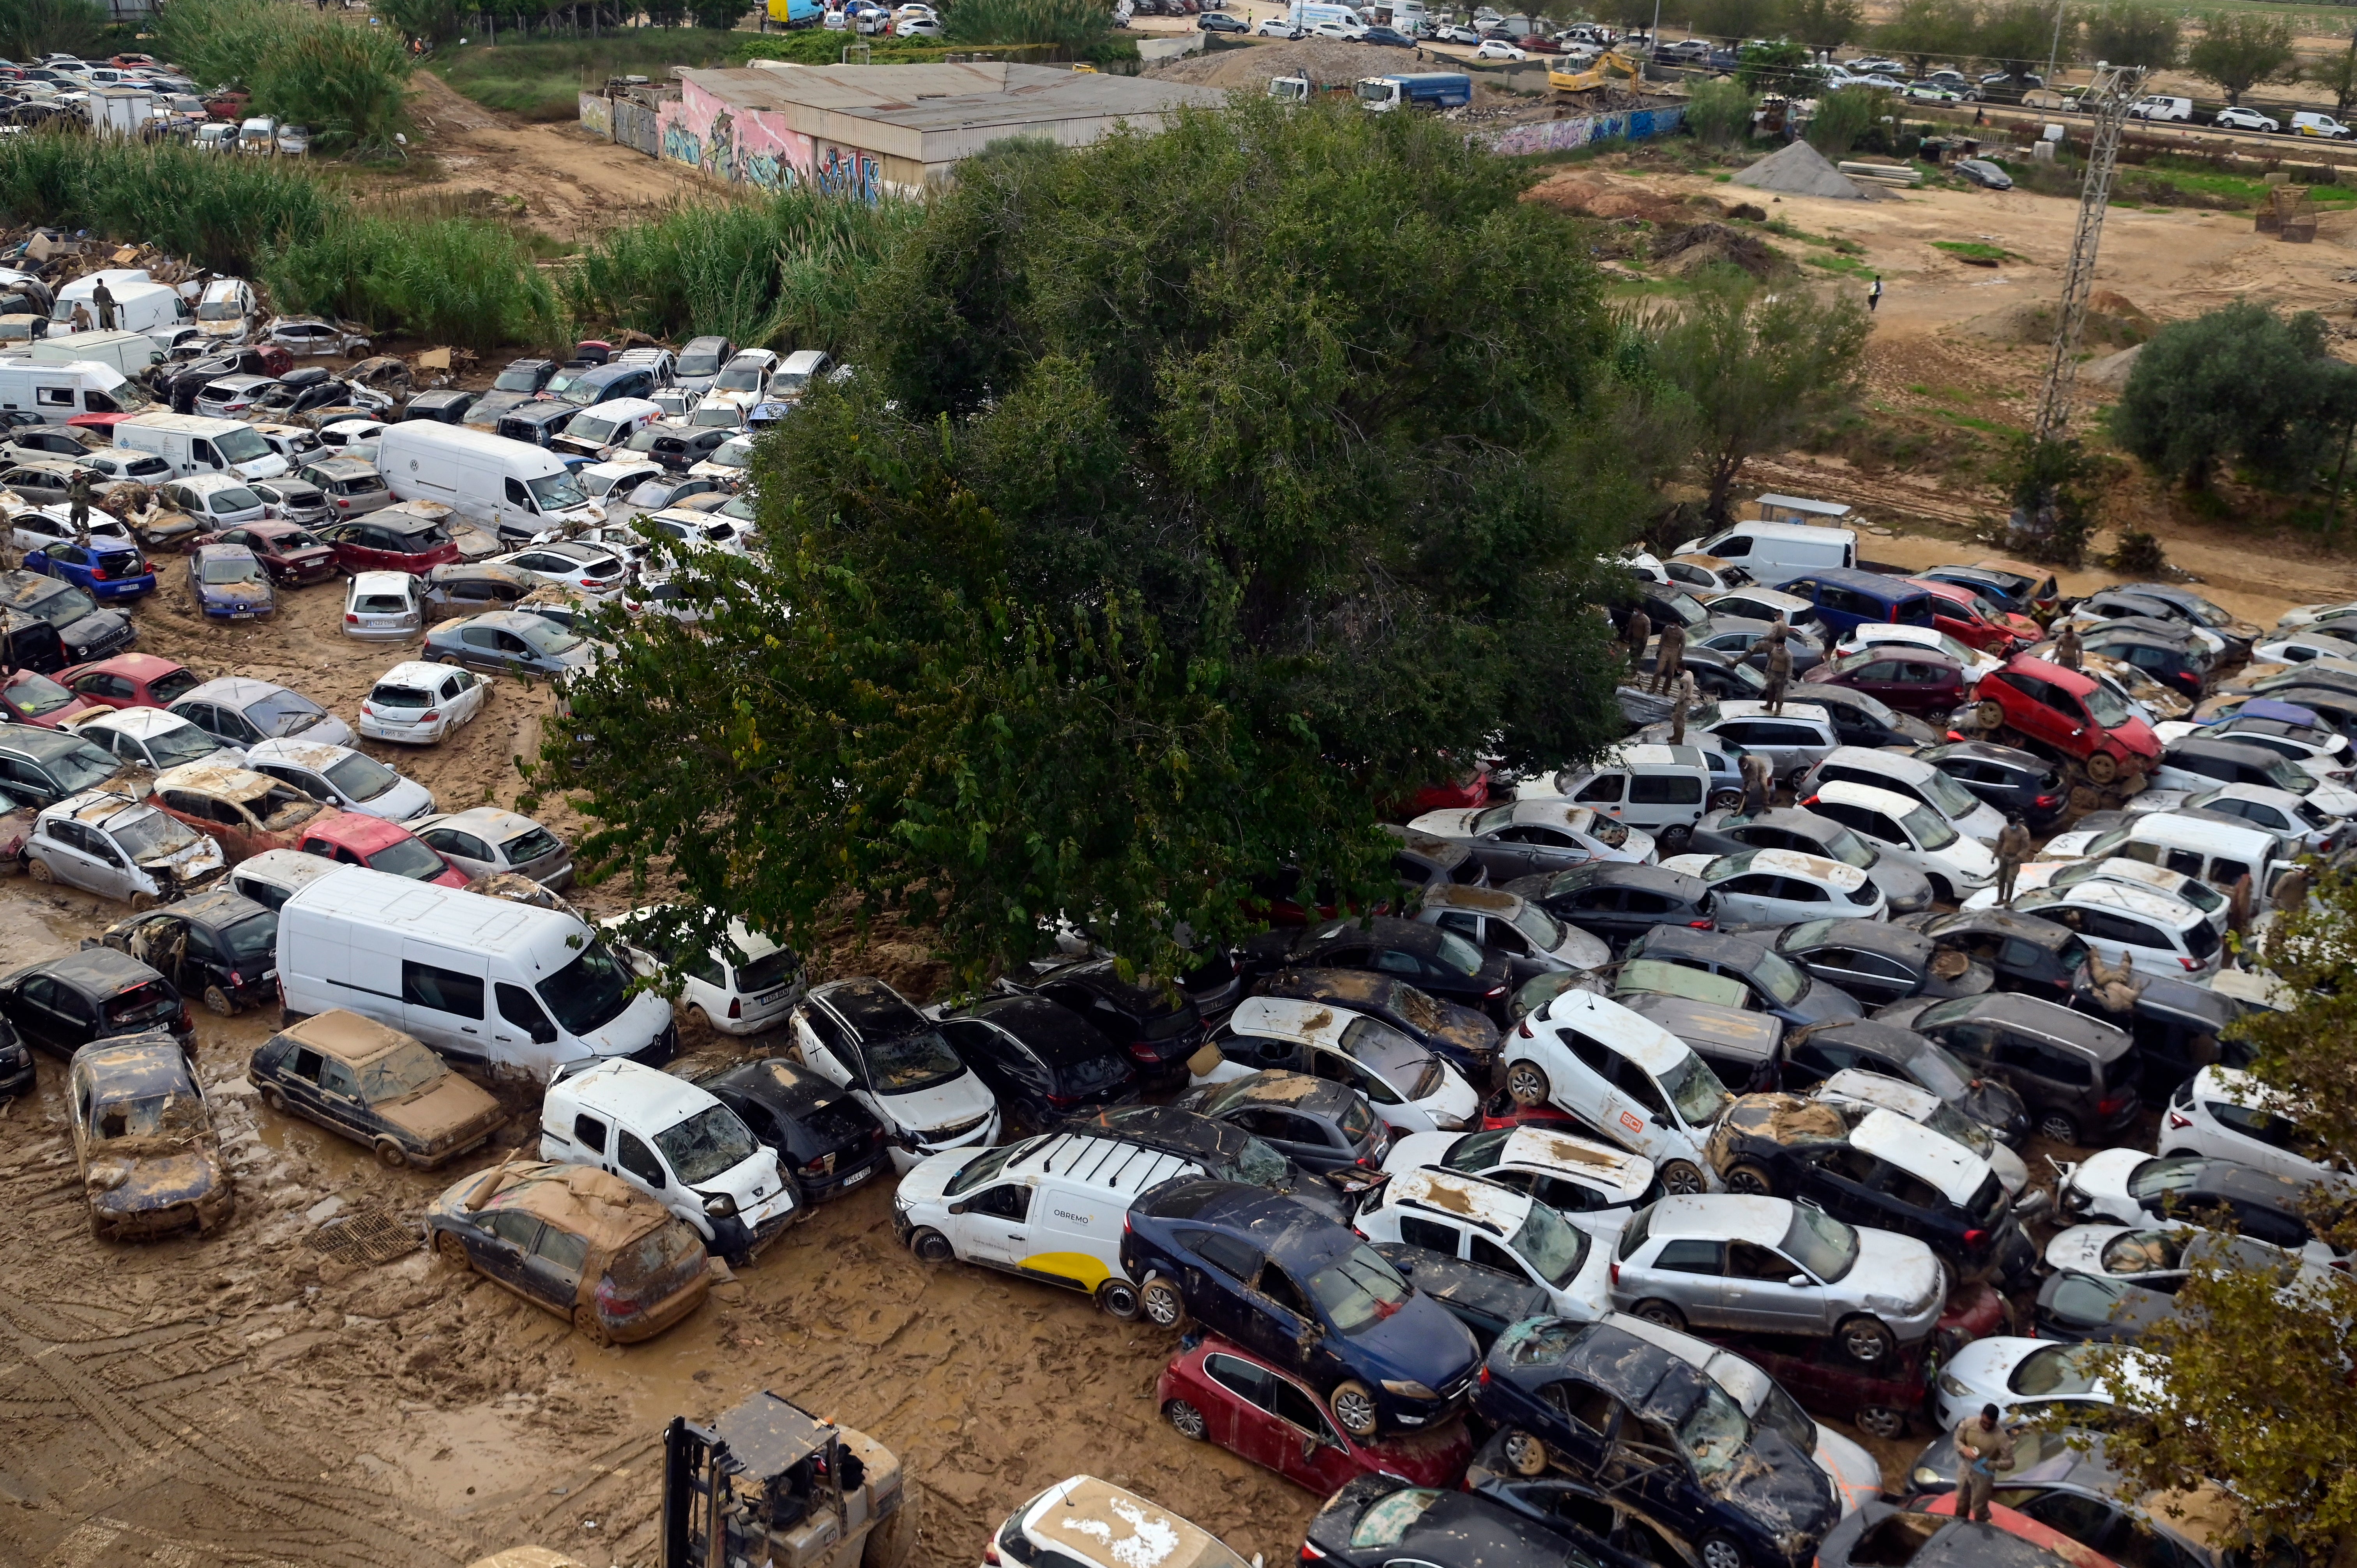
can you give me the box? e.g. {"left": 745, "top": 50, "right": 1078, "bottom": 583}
{"left": 424, "top": 1158, "right": 712, "bottom": 1344}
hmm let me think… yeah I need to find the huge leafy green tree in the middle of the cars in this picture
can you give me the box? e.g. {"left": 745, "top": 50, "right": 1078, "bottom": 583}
{"left": 535, "top": 101, "right": 1648, "bottom": 981}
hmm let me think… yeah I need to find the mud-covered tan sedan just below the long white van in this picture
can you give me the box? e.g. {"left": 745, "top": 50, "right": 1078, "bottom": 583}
{"left": 245, "top": 1009, "right": 507, "bottom": 1169}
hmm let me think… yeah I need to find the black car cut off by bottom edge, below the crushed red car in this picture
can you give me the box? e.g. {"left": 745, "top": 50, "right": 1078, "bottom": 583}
{"left": 1301, "top": 1474, "right": 1640, "bottom": 1568}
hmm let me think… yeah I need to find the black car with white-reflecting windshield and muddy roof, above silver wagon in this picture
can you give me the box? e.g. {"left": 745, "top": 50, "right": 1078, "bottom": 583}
{"left": 1704, "top": 1094, "right": 2039, "bottom": 1283}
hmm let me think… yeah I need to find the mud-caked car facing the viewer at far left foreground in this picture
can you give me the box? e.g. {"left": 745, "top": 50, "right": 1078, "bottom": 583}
{"left": 68, "top": 1030, "right": 236, "bottom": 1240}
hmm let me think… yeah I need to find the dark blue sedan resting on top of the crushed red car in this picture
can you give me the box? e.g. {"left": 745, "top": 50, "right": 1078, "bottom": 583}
{"left": 1122, "top": 1177, "right": 1480, "bottom": 1438}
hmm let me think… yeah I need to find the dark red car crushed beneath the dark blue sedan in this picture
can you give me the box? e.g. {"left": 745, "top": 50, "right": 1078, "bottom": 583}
{"left": 1155, "top": 1337, "right": 1473, "bottom": 1497}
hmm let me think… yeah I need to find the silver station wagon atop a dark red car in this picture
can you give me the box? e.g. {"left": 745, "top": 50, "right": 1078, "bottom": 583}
{"left": 1612, "top": 1193, "right": 1947, "bottom": 1365}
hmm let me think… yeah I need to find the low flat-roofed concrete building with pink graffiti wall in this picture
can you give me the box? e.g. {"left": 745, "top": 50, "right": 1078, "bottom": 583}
{"left": 613, "top": 61, "right": 1228, "bottom": 200}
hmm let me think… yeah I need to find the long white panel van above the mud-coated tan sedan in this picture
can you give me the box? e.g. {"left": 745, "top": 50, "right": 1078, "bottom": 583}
{"left": 278, "top": 865, "right": 679, "bottom": 1082}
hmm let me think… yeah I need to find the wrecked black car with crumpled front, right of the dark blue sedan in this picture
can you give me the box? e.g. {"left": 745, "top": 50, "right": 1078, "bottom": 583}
{"left": 1470, "top": 1318, "right": 1841, "bottom": 1568}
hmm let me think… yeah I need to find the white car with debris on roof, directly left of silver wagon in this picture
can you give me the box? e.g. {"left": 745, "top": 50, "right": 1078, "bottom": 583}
{"left": 1351, "top": 1167, "right": 1612, "bottom": 1323}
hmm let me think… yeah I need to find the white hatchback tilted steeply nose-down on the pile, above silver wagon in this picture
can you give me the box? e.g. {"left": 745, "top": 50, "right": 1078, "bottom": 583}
{"left": 1502, "top": 990, "right": 1735, "bottom": 1193}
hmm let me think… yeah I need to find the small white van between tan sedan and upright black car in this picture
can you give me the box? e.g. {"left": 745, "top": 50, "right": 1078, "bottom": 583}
{"left": 540, "top": 1056, "right": 794, "bottom": 1266}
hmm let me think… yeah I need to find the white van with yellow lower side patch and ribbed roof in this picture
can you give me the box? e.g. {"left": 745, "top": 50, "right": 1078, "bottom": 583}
{"left": 891, "top": 1132, "right": 1205, "bottom": 1318}
